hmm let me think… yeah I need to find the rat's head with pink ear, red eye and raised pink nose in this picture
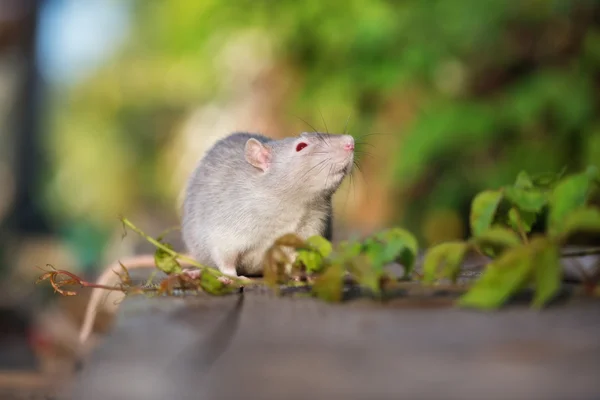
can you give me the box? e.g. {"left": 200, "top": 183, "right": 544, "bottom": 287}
{"left": 245, "top": 133, "right": 354, "bottom": 196}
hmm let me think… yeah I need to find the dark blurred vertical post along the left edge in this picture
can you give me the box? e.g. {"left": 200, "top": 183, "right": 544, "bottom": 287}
{"left": 0, "top": 0, "right": 50, "bottom": 370}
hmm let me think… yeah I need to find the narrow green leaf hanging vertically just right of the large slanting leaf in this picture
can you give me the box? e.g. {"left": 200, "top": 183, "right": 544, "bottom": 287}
{"left": 531, "top": 239, "right": 562, "bottom": 308}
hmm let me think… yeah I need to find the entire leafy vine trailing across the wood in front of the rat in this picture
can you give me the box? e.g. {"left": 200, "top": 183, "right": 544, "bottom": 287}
{"left": 38, "top": 167, "right": 600, "bottom": 309}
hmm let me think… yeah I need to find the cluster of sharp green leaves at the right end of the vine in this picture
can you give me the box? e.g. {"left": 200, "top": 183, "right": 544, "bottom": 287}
{"left": 423, "top": 167, "right": 600, "bottom": 309}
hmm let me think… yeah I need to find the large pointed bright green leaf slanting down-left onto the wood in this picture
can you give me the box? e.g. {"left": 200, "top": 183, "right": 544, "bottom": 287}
{"left": 459, "top": 246, "right": 533, "bottom": 310}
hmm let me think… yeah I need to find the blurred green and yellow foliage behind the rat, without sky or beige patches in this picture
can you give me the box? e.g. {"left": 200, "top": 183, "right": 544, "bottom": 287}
{"left": 43, "top": 0, "right": 600, "bottom": 245}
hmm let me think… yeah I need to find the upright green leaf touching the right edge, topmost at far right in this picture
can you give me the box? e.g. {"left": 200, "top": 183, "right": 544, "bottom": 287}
{"left": 548, "top": 168, "right": 597, "bottom": 235}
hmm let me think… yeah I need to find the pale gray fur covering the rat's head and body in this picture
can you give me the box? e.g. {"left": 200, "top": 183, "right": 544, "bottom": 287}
{"left": 182, "top": 133, "right": 354, "bottom": 276}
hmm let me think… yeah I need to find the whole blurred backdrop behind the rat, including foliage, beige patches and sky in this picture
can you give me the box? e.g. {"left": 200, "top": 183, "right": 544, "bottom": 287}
{"left": 1, "top": 0, "right": 600, "bottom": 278}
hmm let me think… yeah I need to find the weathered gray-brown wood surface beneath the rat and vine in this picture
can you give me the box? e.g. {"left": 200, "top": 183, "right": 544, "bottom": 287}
{"left": 69, "top": 278, "right": 600, "bottom": 400}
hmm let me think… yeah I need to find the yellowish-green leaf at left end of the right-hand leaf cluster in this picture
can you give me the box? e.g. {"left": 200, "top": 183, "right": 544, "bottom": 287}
{"left": 423, "top": 242, "right": 469, "bottom": 283}
